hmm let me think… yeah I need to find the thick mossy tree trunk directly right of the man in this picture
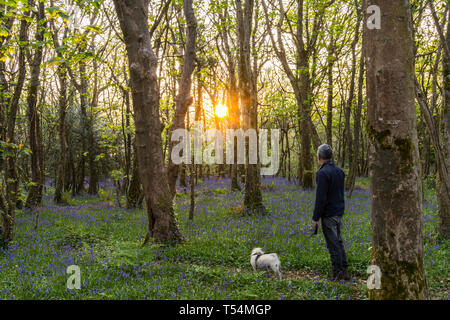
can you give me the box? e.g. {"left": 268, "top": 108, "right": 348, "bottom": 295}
{"left": 364, "top": 0, "right": 427, "bottom": 299}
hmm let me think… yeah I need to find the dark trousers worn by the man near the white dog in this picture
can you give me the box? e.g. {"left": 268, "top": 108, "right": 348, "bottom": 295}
{"left": 322, "top": 216, "right": 348, "bottom": 276}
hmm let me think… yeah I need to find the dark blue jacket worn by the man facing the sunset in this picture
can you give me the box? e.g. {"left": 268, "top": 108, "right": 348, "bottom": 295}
{"left": 313, "top": 160, "right": 345, "bottom": 221}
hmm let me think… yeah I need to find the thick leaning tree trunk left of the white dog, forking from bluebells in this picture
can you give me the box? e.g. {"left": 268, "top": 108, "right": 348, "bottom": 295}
{"left": 114, "top": 0, "right": 182, "bottom": 244}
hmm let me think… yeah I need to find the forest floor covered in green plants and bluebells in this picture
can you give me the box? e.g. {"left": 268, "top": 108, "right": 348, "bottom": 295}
{"left": 0, "top": 178, "right": 450, "bottom": 299}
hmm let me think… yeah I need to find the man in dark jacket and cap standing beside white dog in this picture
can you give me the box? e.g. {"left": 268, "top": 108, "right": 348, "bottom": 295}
{"left": 312, "top": 144, "right": 350, "bottom": 280}
